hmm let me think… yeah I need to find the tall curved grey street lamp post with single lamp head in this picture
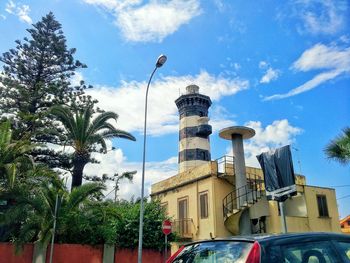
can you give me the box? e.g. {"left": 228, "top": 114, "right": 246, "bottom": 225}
{"left": 137, "top": 55, "right": 167, "bottom": 263}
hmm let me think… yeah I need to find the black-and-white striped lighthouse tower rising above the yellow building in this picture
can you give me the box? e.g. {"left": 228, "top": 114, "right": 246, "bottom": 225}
{"left": 175, "top": 85, "right": 212, "bottom": 173}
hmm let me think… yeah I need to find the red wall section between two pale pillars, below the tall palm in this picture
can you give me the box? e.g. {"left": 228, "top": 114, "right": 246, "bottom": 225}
{"left": 46, "top": 244, "right": 103, "bottom": 263}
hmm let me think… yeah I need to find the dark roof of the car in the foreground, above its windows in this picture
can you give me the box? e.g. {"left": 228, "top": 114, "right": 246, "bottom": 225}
{"left": 182, "top": 232, "right": 350, "bottom": 248}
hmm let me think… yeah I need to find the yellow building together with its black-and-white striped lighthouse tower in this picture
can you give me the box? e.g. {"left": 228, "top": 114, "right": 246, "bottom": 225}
{"left": 151, "top": 85, "right": 340, "bottom": 252}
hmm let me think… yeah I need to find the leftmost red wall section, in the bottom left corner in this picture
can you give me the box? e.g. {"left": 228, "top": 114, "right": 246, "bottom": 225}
{"left": 0, "top": 243, "right": 34, "bottom": 263}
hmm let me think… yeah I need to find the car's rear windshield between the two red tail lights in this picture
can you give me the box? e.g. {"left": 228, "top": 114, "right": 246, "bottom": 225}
{"left": 173, "top": 241, "right": 253, "bottom": 263}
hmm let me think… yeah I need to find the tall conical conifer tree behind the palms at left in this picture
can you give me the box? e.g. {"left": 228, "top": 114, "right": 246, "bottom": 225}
{"left": 0, "top": 13, "right": 91, "bottom": 168}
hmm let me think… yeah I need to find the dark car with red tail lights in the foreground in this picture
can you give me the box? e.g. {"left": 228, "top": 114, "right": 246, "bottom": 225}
{"left": 167, "top": 233, "right": 350, "bottom": 263}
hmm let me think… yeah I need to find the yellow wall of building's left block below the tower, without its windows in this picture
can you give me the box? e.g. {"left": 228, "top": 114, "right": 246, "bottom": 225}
{"left": 152, "top": 162, "right": 234, "bottom": 242}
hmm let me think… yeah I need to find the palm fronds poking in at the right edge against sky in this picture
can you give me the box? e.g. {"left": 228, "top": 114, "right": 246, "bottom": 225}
{"left": 324, "top": 127, "right": 350, "bottom": 165}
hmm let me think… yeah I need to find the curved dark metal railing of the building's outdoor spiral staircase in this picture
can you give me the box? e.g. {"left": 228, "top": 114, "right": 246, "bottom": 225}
{"left": 223, "top": 178, "right": 263, "bottom": 220}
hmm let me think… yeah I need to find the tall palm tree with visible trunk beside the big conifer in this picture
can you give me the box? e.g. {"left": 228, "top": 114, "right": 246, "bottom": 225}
{"left": 51, "top": 106, "right": 136, "bottom": 191}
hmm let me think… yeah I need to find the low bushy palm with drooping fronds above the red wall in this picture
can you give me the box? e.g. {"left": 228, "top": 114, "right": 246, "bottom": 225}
{"left": 0, "top": 180, "right": 105, "bottom": 248}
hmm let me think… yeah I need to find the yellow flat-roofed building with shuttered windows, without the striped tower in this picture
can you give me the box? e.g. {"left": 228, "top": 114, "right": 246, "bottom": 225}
{"left": 151, "top": 157, "right": 340, "bottom": 252}
